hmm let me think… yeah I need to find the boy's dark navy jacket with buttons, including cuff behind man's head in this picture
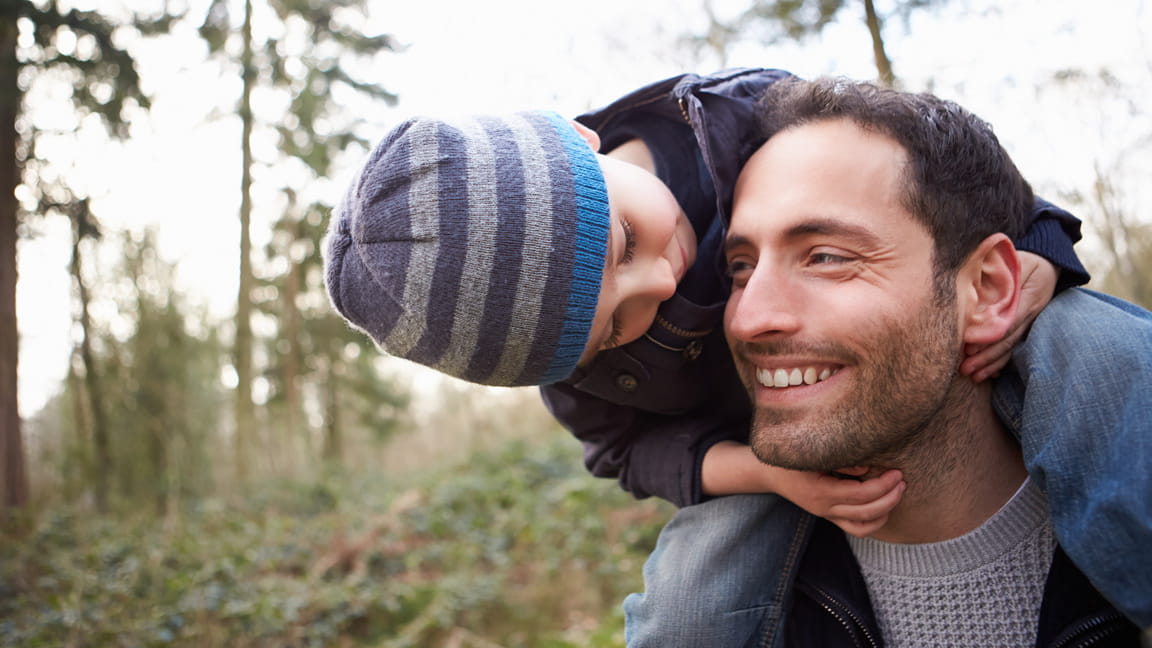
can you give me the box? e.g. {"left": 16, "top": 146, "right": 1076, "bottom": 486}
{"left": 541, "top": 68, "right": 1089, "bottom": 506}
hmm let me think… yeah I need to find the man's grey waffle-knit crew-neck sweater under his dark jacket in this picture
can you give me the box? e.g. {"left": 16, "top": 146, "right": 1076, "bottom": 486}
{"left": 849, "top": 480, "right": 1056, "bottom": 648}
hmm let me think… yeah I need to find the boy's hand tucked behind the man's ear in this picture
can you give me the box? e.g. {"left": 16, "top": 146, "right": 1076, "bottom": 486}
{"left": 960, "top": 251, "right": 1058, "bottom": 383}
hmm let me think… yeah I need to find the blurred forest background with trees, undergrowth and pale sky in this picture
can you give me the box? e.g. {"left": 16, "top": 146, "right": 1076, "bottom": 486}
{"left": 0, "top": 0, "right": 1152, "bottom": 648}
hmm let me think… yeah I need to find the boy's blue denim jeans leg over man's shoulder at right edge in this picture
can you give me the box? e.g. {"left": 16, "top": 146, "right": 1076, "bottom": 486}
{"left": 993, "top": 288, "right": 1152, "bottom": 638}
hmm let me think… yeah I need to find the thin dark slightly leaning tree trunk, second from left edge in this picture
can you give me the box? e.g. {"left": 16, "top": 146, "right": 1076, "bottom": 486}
{"left": 71, "top": 217, "right": 115, "bottom": 513}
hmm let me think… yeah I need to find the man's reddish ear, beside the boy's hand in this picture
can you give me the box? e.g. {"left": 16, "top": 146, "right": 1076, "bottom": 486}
{"left": 956, "top": 234, "right": 1020, "bottom": 345}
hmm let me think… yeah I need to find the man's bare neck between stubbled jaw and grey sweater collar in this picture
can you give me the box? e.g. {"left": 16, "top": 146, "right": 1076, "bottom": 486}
{"left": 872, "top": 378, "right": 1028, "bottom": 544}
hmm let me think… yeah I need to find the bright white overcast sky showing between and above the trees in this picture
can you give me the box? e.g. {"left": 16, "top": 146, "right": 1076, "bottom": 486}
{"left": 17, "top": 0, "right": 1152, "bottom": 415}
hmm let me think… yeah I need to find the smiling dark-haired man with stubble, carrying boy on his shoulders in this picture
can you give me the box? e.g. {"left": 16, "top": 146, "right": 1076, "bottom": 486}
{"left": 726, "top": 81, "right": 1137, "bottom": 647}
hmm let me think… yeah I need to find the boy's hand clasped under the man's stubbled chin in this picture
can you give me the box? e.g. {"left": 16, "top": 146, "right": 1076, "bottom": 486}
{"left": 776, "top": 468, "right": 905, "bottom": 537}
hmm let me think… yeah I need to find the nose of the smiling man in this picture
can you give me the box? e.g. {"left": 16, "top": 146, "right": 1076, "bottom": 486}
{"left": 725, "top": 268, "right": 803, "bottom": 341}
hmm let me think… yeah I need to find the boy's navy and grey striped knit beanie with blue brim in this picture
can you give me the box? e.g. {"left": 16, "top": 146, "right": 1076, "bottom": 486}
{"left": 326, "top": 112, "right": 608, "bottom": 386}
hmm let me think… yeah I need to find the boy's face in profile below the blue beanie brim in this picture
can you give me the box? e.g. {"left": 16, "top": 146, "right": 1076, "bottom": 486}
{"left": 581, "top": 155, "right": 696, "bottom": 363}
